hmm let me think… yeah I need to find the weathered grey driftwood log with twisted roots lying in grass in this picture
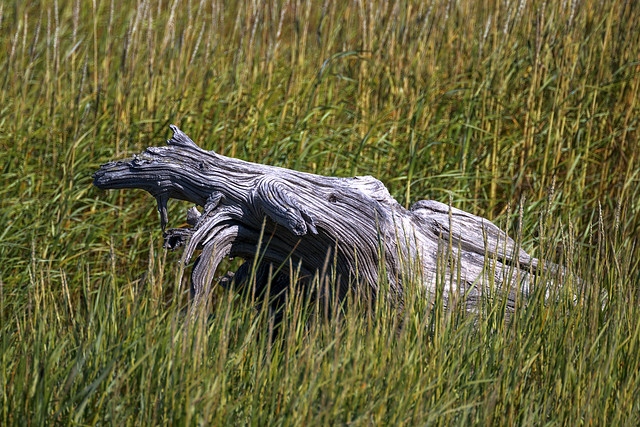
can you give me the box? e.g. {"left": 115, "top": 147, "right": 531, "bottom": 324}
{"left": 94, "top": 126, "right": 538, "bottom": 316}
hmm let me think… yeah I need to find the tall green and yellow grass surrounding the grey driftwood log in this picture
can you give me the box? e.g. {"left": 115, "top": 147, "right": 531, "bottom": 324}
{"left": 0, "top": 0, "right": 640, "bottom": 425}
